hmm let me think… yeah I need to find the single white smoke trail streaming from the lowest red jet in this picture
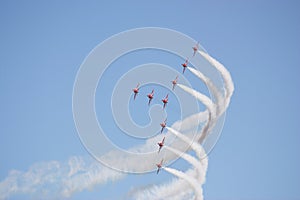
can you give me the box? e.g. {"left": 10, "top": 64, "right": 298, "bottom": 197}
{"left": 164, "top": 167, "right": 203, "bottom": 200}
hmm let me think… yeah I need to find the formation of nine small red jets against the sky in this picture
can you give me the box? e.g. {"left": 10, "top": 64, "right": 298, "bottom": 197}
{"left": 132, "top": 42, "right": 199, "bottom": 174}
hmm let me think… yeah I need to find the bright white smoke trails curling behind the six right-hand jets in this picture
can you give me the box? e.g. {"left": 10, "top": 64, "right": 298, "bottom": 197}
{"left": 137, "top": 51, "right": 234, "bottom": 200}
